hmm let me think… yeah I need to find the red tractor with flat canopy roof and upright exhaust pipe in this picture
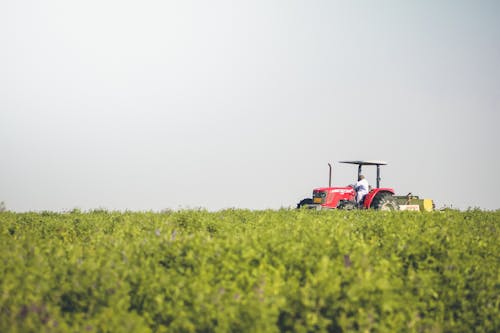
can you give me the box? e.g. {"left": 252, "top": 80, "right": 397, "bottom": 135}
{"left": 297, "top": 161, "right": 400, "bottom": 210}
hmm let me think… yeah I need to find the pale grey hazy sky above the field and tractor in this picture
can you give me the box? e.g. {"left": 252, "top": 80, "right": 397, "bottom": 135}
{"left": 0, "top": 0, "right": 500, "bottom": 211}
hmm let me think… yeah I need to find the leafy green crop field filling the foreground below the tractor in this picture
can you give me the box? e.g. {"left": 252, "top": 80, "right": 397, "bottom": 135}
{"left": 0, "top": 210, "right": 500, "bottom": 332}
